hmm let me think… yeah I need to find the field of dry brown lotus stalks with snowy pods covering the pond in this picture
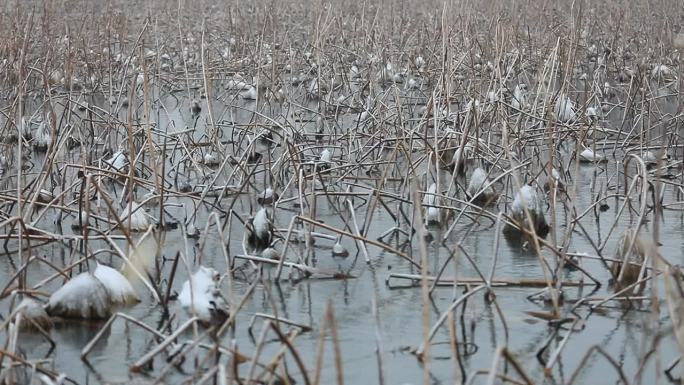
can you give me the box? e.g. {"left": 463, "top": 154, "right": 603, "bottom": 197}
{"left": 0, "top": 0, "right": 684, "bottom": 384}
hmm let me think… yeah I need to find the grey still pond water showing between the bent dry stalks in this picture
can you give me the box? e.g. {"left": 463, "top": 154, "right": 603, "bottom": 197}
{"left": 0, "top": 80, "right": 684, "bottom": 384}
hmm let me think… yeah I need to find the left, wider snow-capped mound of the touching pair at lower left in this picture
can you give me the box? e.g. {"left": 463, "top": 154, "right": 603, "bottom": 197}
{"left": 45, "top": 272, "right": 112, "bottom": 319}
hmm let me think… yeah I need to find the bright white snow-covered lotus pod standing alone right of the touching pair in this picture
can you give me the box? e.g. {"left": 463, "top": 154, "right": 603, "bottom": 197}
{"left": 178, "top": 266, "right": 228, "bottom": 323}
